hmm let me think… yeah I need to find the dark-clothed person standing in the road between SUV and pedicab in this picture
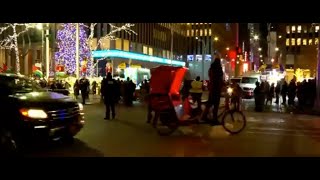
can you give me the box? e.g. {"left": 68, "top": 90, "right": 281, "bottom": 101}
{"left": 101, "top": 73, "right": 119, "bottom": 120}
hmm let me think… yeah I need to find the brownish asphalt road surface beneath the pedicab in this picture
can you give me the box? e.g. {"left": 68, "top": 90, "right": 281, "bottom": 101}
{"left": 27, "top": 100, "right": 320, "bottom": 157}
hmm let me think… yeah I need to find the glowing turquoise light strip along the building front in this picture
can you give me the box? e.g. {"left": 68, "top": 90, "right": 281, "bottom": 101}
{"left": 92, "top": 50, "right": 186, "bottom": 66}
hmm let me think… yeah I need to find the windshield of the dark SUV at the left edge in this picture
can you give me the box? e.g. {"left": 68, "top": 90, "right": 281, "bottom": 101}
{"left": 0, "top": 76, "right": 44, "bottom": 93}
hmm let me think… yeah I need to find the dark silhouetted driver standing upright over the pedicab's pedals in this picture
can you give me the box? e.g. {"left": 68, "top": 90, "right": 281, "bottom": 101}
{"left": 203, "top": 56, "right": 223, "bottom": 124}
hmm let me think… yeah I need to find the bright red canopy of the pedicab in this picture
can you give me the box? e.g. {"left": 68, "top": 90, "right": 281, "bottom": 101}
{"left": 150, "top": 66, "right": 187, "bottom": 95}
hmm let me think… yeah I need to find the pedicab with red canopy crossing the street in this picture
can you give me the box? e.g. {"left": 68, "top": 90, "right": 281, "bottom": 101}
{"left": 148, "top": 66, "right": 246, "bottom": 135}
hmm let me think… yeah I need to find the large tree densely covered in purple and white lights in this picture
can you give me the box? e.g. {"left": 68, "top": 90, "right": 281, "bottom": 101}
{"left": 54, "top": 23, "right": 92, "bottom": 75}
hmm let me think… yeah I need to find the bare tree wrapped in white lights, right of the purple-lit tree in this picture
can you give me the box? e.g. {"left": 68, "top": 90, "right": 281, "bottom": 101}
{"left": 87, "top": 23, "right": 137, "bottom": 76}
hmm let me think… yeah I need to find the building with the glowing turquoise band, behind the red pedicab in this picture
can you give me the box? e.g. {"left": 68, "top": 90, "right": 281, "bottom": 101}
{"left": 94, "top": 23, "right": 187, "bottom": 74}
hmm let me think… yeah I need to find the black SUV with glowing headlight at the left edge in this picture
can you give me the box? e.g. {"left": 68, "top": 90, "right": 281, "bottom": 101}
{"left": 0, "top": 74, "right": 84, "bottom": 155}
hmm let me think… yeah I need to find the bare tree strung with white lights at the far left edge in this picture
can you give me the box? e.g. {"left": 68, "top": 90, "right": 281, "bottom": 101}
{"left": 0, "top": 23, "right": 34, "bottom": 74}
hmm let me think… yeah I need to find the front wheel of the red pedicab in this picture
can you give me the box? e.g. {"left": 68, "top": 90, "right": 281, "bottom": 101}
{"left": 222, "top": 111, "right": 247, "bottom": 134}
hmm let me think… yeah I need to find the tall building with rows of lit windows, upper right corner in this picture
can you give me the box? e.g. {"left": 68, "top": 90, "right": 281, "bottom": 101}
{"left": 277, "top": 23, "right": 319, "bottom": 77}
